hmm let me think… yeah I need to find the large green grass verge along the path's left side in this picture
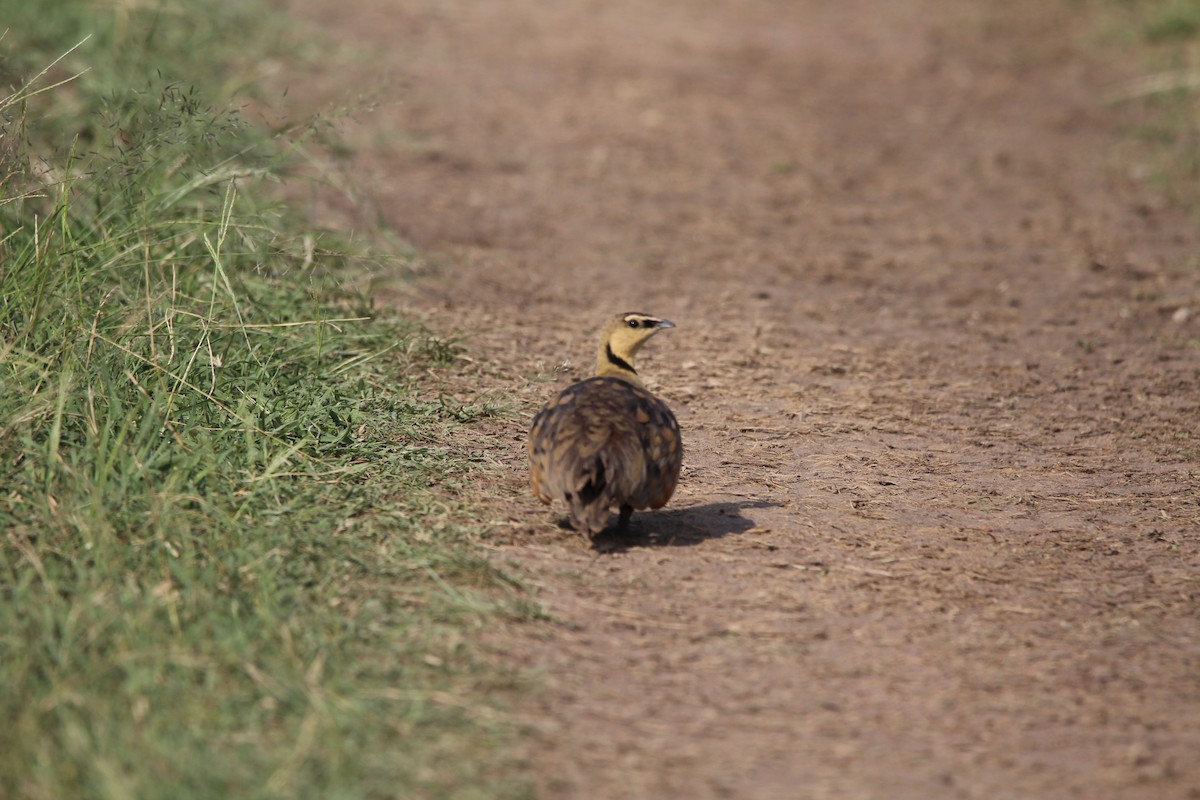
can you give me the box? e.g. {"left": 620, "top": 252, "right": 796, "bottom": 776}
{"left": 0, "top": 0, "right": 526, "bottom": 800}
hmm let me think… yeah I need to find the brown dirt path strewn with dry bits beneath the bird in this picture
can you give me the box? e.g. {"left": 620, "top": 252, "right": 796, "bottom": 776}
{"left": 285, "top": 0, "right": 1200, "bottom": 799}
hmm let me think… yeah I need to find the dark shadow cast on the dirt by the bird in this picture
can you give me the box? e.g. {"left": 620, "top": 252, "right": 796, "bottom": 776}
{"left": 576, "top": 500, "right": 784, "bottom": 553}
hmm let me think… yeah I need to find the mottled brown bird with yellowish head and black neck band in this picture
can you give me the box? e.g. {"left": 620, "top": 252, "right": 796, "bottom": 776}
{"left": 529, "top": 312, "right": 683, "bottom": 539}
